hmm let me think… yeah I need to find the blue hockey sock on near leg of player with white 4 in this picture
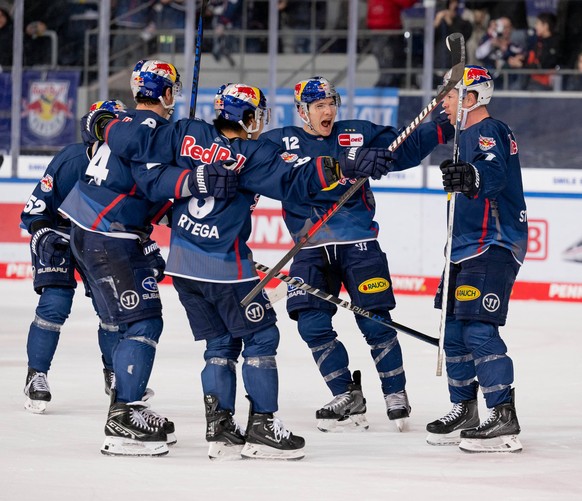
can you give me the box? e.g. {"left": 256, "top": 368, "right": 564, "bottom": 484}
{"left": 113, "top": 317, "right": 163, "bottom": 402}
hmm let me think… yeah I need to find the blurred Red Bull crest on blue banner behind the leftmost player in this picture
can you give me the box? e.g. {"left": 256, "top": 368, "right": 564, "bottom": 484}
{"left": 22, "top": 81, "right": 73, "bottom": 138}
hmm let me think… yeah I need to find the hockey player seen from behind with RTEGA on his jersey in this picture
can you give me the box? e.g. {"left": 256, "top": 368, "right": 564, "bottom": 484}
{"left": 80, "top": 84, "right": 391, "bottom": 459}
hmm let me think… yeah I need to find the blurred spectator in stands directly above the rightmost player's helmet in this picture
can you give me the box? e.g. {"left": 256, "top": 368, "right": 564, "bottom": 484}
{"left": 475, "top": 17, "right": 525, "bottom": 89}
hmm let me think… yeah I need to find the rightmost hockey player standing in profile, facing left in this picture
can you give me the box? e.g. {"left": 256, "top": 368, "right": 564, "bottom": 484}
{"left": 426, "top": 66, "right": 527, "bottom": 452}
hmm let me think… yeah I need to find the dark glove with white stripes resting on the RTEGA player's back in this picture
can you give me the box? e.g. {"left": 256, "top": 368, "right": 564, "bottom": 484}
{"left": 188, "top": 160, "right": 238, "bottom": 200}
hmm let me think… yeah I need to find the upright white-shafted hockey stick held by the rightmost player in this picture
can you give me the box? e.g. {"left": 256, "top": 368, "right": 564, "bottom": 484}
{"left": 436, "top": 35, "right": 467, "bottom": 376}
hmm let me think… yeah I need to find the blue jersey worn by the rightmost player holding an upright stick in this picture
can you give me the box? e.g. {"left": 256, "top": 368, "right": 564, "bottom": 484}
{"left": 451, "top": 118, "right": 527, "bottom": 264}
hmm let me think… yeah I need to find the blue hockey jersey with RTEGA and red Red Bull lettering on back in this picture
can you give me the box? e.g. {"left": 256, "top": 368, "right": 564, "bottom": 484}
{"left": 105, "top": 115, "right": 336, "bottom": 282}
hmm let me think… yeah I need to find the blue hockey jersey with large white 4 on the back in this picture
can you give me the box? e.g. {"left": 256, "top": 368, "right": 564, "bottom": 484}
{"left": 59, "top": 110, "right": 170, "bottom": 239}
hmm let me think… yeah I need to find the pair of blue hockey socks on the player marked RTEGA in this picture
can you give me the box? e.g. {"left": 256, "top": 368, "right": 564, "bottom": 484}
{"left": 202, "top": 326, "right": 279, "bottom": 414}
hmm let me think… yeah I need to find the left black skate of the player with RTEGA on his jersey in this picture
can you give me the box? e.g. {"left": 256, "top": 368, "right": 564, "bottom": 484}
{"left": 204, "top": 395, "right": 245, "bottom": 460}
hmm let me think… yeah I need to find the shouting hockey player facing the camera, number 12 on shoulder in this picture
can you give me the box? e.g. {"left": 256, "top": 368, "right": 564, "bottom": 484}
{"left": 261, "top": 76, "right": 454, "bottom": 431}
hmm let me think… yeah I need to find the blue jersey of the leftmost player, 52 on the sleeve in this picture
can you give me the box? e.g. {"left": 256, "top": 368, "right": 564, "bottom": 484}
{"left": 20, "top": 143, "right": 89, "bottom": 234}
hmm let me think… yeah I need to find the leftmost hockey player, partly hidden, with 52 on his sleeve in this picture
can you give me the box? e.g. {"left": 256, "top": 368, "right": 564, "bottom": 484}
{"left": 21, "top": 100, "right": 125, "bottom": 414}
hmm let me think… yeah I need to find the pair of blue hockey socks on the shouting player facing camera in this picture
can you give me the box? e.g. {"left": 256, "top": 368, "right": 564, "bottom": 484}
{"left": 298, "top": 309, "right": 406, "bottom": 395}
